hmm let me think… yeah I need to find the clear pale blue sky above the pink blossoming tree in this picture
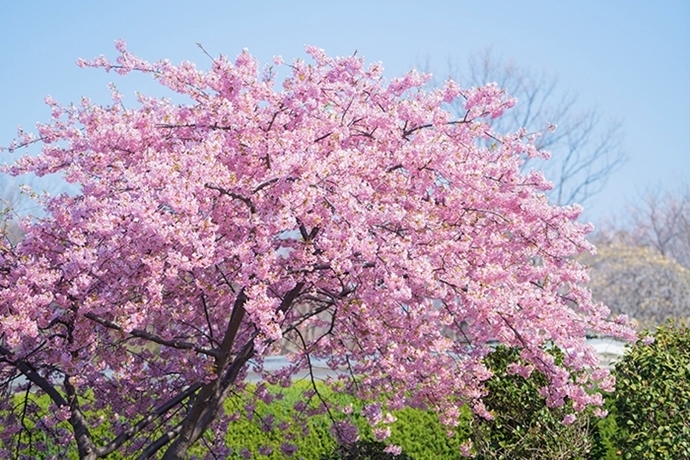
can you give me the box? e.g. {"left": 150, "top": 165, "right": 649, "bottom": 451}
{"left": 0, "top": 0, "right": 690, "bottom": 222}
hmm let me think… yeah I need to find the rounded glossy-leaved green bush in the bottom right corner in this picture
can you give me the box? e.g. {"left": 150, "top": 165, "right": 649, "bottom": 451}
{"left": 612, "top": 322, "right": 690, "bottom": 460}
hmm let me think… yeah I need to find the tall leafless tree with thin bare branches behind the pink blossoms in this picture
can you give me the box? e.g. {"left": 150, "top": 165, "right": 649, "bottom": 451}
{"left": 426, "top": 48, "right": 626, "bottom": 205}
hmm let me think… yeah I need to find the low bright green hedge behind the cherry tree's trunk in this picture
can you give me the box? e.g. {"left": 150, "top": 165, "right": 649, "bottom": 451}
{"left": 0, "top": 383, "right": 470, "bottom": 460}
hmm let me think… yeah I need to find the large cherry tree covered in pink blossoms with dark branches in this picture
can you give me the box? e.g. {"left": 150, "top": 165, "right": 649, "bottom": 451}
{"left": 0, "top": 42, "right": 634, "bottom": 459}
